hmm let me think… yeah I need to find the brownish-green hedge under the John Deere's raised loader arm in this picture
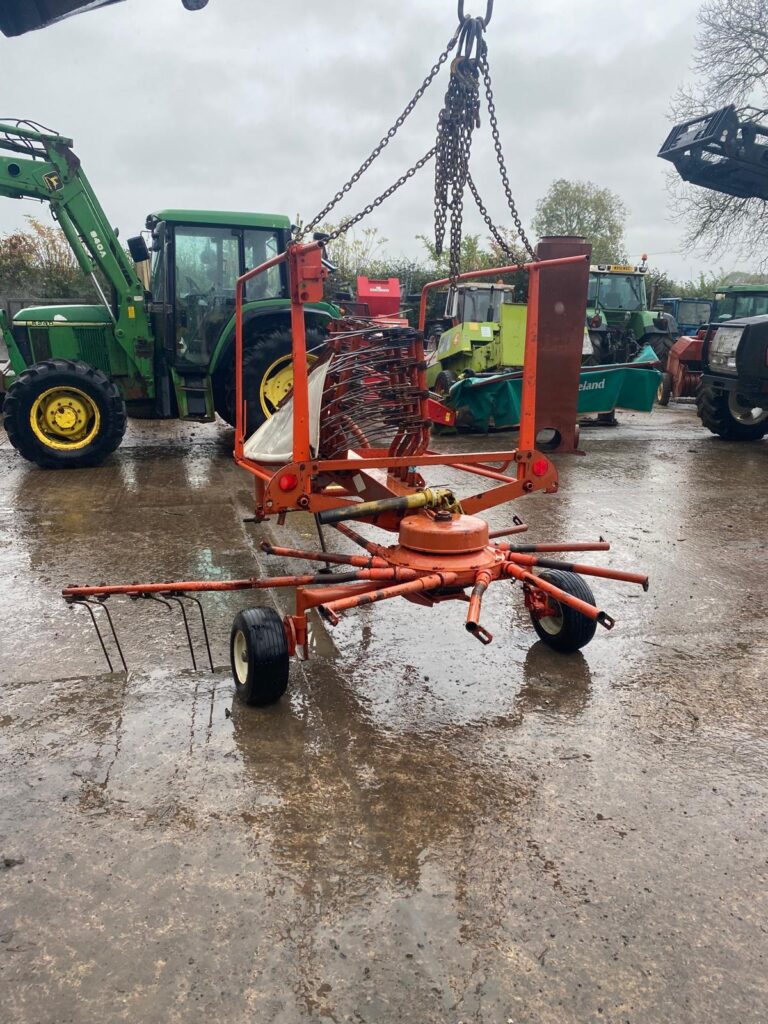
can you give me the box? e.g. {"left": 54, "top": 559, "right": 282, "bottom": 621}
{"left": 0, "top": 216, "right": 97, "bottom": 301}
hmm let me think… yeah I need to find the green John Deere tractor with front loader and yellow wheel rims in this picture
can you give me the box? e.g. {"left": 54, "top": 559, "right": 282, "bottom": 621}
{"left": 0, "top": 122, "right": 339, "bottom": 468}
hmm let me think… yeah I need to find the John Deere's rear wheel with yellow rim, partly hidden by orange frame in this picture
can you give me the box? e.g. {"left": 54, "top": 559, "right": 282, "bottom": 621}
{"left": 223, "top": 330, "right": 326, "bottom": 437}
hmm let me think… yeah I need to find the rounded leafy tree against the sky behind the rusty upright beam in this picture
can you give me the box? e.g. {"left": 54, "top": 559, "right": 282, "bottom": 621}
{"left": 532, "top": 178, "right": 627, "bottom": 263}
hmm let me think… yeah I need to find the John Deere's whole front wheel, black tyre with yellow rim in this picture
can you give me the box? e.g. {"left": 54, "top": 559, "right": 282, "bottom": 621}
{"left": 5, "top": 359, "right": 126, "bottom": 469}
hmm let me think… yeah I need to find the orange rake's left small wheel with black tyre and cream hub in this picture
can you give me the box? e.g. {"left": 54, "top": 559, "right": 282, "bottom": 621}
{"left": 229, "top": 608, "right": 289, "bottom": 708}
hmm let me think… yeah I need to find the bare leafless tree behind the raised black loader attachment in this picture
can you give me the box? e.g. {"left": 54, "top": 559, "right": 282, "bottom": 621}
{"left": 670, "top": 0, "right": 768, "bottom": 267}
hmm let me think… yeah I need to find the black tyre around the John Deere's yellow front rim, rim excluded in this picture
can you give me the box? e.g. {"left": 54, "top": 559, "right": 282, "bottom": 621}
{"left": 4, "top": 359, "right": 127, "bottom": 469}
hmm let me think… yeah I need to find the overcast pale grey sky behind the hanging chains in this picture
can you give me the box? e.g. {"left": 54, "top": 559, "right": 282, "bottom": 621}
{"left": 0, "top": 0, "right": 749, "bottom": 278}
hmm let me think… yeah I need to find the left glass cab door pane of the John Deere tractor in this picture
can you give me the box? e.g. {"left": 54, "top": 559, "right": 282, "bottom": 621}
{"left": 174, "top": 224, "right": 240, "bottom": 367}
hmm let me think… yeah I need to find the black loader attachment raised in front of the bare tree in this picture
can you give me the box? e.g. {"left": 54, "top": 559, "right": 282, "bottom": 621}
{"left": 658, "top": 103, "right": 768, "bottom": 200}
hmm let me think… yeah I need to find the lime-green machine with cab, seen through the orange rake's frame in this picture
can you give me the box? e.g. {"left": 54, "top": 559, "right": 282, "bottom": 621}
{"left": 427, "top": 284, "right": 527, "bottom": 395}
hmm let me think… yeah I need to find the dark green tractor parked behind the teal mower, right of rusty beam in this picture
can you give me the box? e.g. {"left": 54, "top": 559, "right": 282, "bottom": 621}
{"left": 586, "top": 257, "right": 677, "bottom": 366}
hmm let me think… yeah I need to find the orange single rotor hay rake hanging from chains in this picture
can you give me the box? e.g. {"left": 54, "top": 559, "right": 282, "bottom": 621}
{"left": 63, "top": 242, "right": 647, "bottom": 705}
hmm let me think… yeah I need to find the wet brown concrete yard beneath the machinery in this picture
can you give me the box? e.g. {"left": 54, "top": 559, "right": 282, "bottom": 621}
{"left": 0, "top": 406, "right": 768, "bottom": 1024}
